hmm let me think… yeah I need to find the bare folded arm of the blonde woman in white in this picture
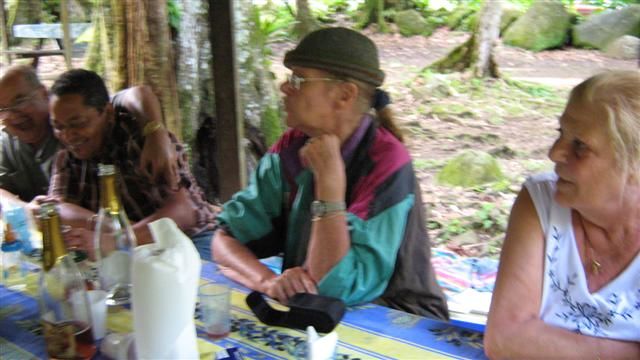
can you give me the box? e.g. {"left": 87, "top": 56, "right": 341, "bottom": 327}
{"left": 484, "top": 188, "right": 640, "bottom": 359}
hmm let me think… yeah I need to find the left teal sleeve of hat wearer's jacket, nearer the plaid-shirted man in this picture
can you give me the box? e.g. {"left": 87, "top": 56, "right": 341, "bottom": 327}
{"left": 217, "top": 153, "right": 285, "bottom": 243}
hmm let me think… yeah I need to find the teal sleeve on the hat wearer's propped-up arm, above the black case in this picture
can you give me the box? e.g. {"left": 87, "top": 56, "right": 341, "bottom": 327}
{"left": 318, "top": 194, "right": 414, "bottom": 305}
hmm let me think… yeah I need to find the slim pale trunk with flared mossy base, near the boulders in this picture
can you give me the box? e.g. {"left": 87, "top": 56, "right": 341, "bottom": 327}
{"left": 427, "top": 0, "right": 502, "bottom": 78}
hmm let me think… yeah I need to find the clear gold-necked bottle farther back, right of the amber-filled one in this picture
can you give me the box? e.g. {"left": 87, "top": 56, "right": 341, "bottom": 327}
{"left": 94, "top": 164, "right": 136, "bottom": 305}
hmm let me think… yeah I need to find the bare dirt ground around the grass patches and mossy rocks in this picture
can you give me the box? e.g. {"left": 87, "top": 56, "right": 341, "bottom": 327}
{"left": 13, "top": 25, "right": 638, "bottom": 255}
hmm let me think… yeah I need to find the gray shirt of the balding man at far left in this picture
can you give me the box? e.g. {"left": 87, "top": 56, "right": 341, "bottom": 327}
{"left": 0, "top": 131, "right": 59, "bottom": 201}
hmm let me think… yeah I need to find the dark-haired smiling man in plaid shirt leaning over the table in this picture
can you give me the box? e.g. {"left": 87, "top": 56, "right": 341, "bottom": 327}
{"left": 49, "top": 69, "right": 216, "bottom": 259}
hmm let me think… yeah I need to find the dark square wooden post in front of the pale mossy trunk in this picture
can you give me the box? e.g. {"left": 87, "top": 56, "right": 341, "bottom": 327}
{"left": 209, "top": 0, "right": 246, "bottom": 201}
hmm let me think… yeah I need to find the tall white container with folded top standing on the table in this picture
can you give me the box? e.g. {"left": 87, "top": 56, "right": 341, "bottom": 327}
{"left": 131, "top": 218, "right": 201, "bottom": 359}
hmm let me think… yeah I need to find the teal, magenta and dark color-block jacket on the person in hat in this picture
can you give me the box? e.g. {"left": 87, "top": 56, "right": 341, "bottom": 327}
{"left": 217, "top": 115, "right": 448, "bottom": 318}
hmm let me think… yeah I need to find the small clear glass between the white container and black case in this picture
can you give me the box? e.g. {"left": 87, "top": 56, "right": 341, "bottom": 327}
{"left": 198, "top": 282, "right": 231, "bottom": 339}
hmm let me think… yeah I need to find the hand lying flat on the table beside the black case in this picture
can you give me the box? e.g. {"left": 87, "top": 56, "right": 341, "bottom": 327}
{"left": 265, "top": 267, "right": 318, "bottom": 305}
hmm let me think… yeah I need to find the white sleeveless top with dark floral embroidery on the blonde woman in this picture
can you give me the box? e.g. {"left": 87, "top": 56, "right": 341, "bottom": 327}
{"left": 525, "top": 173, "right": 640, "bottom": 341}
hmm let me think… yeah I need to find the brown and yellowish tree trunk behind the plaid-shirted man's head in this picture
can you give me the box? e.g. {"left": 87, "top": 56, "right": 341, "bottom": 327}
{"left": 88, "top": 0, "right": 182, "bottom": 139}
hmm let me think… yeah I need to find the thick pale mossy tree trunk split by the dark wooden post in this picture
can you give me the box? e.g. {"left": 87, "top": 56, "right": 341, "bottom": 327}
{"left": 177, "top": 0, "right": 284, "bottom": 202}
